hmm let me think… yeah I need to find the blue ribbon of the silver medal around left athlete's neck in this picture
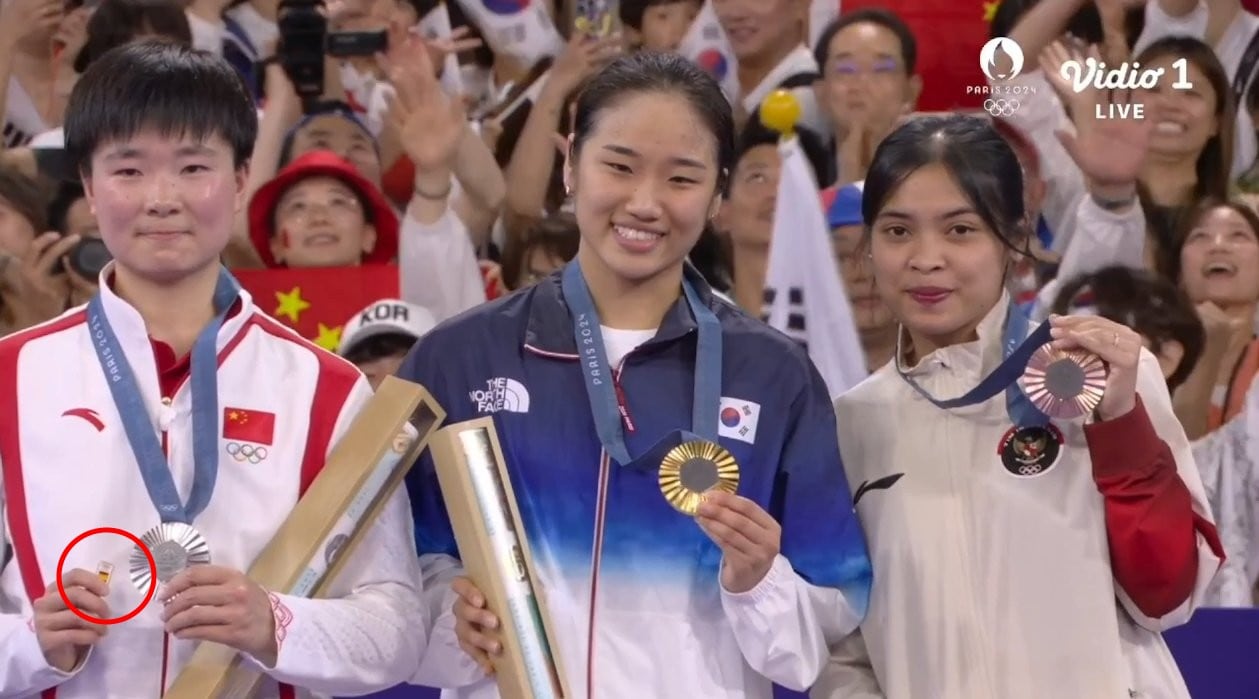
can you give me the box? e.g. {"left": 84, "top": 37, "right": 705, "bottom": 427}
{"left": 87, "top": 268, "right": 240, "bottom": 524}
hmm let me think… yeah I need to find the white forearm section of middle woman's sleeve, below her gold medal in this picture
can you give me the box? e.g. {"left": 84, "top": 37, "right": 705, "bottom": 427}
{"left": 721, "top": 554, "right": 861, "bottom": 691}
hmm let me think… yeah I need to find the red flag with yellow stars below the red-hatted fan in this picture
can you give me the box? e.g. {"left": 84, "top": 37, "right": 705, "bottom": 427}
{"left": 232, "top": 264, "right": 398, "bottom": 351}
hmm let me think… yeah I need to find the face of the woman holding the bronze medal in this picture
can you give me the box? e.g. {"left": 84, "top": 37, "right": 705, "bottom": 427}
{"left": 870, "top": 164, "right": 1010, "bottom": 356}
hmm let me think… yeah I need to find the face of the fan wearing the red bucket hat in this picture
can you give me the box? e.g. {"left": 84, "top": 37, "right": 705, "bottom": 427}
{"left": 271, "top": 176, "right": 376, "bottom": 267}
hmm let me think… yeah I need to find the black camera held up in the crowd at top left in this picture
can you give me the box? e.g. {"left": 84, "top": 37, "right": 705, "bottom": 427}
{"left": 276, "top": 0, "right": 389, "bottom": 107}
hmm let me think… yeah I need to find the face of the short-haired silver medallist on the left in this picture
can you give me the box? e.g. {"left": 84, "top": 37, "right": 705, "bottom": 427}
{"left": 83, "top": 130, "right": 246, "bottom": 283}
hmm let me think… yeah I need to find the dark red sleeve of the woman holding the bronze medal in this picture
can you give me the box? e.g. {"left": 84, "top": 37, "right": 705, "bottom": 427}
{"left": 1084, "top": 395, "right": 1219, "bottom": 618}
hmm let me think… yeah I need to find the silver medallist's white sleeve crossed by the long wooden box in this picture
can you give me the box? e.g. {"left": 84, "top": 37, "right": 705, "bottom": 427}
{"left": 240, "top": 378, "right": 428, "bottom": 695}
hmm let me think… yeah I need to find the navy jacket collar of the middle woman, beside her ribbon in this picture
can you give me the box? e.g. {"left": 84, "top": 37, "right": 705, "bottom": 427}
{"left": 525, "top": 262, "right": 719, "bottom": 356}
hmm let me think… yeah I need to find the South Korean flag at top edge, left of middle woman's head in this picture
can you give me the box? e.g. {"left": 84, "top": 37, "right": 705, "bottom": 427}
{"left": 458, "top": 0, "right": 564, "bottom": 67}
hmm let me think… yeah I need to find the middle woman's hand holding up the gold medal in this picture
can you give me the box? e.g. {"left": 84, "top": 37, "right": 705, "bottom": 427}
{"left": 695, "top": 491, "right": 783, "bottom": 594}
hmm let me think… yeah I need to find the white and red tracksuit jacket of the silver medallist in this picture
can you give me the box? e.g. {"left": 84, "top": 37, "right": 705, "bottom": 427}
{"left": 0, "top": 275, "right": 426, "bottom": 699}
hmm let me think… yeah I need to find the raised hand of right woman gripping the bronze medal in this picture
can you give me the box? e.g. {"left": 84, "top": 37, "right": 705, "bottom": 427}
{"left": 1049, "top": 315, "right": 1144, "bottom": 419}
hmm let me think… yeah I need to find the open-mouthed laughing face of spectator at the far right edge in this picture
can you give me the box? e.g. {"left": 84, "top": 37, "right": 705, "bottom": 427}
{"left": 1181, "top": 207, "right": 1259, "bottom": 307}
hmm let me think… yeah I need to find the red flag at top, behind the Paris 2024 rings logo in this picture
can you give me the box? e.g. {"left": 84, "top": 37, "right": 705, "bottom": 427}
{"left": 842, "top": 0, "right": 1001, "bottom": 112}
